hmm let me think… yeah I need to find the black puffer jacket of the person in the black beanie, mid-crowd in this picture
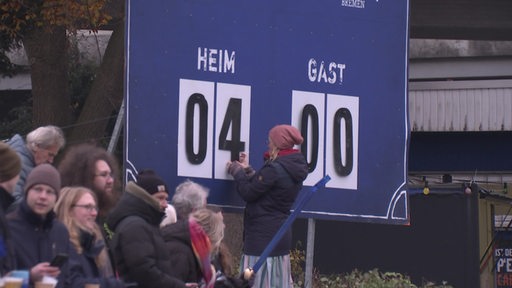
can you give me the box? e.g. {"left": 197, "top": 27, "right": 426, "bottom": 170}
{"left": 106, "top": 182, "right": 186, "bottom": 288}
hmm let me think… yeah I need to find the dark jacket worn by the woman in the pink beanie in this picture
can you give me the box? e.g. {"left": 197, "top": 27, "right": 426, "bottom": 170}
{"left": 234, "top": 150, "right": 308, "bottom": 257}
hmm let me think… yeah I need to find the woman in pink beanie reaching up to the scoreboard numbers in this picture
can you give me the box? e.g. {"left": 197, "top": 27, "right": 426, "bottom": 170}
{"left": 227, "top": 125, "right": 308, "bottom": 288}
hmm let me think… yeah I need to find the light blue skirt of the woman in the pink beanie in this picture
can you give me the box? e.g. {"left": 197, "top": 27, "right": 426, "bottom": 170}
{"left": 240, "top": 254, "right": 293, "bottom": 288}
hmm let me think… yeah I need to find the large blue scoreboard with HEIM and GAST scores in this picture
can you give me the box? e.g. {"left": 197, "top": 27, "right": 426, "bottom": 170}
{"left": 125, "top": 0, "right": 409, "bottom": 224}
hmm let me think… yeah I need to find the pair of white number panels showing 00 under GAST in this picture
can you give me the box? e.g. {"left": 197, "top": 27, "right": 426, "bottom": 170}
{"left": 292, "top": 91, "right": 359, "bottom": 190}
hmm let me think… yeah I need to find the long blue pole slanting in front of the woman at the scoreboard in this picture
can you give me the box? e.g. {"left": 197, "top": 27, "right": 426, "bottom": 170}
{"left": 246, "top": 175, "right": 331, "bottom": 278}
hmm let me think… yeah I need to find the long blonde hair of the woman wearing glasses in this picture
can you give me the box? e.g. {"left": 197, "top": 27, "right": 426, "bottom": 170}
{"left": 54, "top": 186, "right": 112, "bottom": 276}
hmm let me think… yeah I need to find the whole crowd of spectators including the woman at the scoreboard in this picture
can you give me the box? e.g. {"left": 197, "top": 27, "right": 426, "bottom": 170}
{"left": 0, "top": 125, "right": 308, "bottom": 288}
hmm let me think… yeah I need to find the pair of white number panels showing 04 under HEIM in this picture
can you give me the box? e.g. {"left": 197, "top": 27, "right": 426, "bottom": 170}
{"left": 177, "top": 79, "right": 251, "bottom": 179}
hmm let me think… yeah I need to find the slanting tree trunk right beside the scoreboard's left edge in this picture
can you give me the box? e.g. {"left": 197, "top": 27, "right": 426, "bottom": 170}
{"left": 68, "top": 21, "right": 124, "bottom": 143}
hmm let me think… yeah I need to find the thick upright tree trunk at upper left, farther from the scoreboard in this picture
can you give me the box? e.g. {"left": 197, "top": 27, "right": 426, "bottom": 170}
{"left": 23, "top": 27, "right": 71, "bottom": 128}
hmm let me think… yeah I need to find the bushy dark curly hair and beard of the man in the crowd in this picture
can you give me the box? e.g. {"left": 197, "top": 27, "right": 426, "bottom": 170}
{"left": 58, "top": 143, "right": 121, "bottom": 219}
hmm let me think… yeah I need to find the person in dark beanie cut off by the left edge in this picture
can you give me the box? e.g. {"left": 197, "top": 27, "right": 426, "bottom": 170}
{"left": 0, "top": 142, "right": 21, "bottom": 275}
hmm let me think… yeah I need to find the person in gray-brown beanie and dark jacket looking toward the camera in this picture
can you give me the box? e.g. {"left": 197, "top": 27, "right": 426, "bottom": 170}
{"left": 7, "top": 164, "right": 79, "bottom": 287}
